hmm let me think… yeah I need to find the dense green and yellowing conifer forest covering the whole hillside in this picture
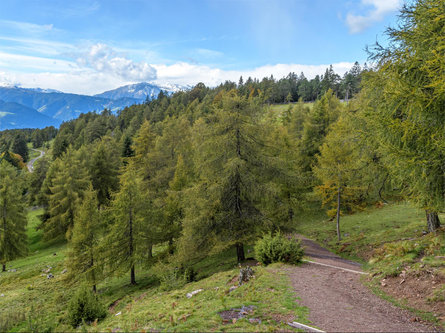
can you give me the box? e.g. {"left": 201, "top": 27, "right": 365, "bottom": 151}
{"left": 0, "top": 0, "right": 445, "bottom": 330}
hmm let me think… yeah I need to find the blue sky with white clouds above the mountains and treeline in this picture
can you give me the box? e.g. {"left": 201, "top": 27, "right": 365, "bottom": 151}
{"left": 0, "top": 0, "right": 403, "bottom": 95}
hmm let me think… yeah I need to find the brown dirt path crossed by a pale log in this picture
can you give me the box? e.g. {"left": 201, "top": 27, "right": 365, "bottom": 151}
{"left": 287, "top": 236, "right": 434, "bottom": 332}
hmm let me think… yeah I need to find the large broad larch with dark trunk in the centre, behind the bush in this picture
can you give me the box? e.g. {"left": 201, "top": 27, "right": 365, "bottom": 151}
{"left": 181, "top": 91, "right": 272, "bottom": 261}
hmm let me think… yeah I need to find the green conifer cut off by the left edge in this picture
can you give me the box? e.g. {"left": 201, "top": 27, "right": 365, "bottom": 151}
{"left": 0, "top": 161, "right": 27, "bottom": 271}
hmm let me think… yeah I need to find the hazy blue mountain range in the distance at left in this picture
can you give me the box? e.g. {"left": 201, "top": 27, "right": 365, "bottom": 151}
{"left": 0, "top": 82, "right": 189, "bottom": 130}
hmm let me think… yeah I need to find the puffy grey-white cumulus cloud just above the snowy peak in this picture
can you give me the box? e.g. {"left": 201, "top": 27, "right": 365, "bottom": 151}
{"left": 77, "top": 43, "right": 156, "bottom": 81}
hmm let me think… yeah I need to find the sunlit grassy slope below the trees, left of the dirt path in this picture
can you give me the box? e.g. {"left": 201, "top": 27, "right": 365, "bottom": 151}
{"left": 0, "top": 210, "right": 308, "bottom": 331}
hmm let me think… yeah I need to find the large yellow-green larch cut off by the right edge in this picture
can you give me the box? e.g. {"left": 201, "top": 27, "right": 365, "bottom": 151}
{"left": 363, "top": 0, "right": 445, "bottom": 232}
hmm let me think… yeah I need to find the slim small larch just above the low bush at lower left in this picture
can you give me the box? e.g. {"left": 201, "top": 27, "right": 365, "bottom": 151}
{"left": 67, "top": 184, "right": 102, "bottom": 292}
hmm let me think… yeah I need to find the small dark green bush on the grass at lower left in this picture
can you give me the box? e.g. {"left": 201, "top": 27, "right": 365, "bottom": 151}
{"left": 68, "top": 286, "right": 107, "bottom": 328}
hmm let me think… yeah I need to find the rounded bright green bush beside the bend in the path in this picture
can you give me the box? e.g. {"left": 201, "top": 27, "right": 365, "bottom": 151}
{"left": 255, "top": 233, "right": 304, "bottom": 265}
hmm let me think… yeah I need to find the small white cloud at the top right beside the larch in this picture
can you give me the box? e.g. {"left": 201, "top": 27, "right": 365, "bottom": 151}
{"left": 346, "top": 0, "right": 402, "bottom": 34}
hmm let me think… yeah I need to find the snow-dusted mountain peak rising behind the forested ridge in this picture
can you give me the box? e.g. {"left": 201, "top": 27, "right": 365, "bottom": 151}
{"left": 94, "top": 82, "right": 190, "bottom": 101}
